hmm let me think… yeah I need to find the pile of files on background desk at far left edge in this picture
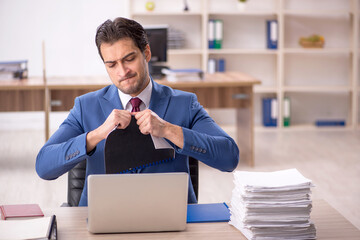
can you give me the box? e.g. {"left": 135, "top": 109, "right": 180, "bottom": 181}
{"left": 0, "top": 60, "right": 28, "bottom": 80}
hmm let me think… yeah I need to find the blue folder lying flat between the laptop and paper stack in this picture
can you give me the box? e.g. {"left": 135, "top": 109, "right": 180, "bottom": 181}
{"left": 187, "top": 203, "right": 230, "bottom": 223}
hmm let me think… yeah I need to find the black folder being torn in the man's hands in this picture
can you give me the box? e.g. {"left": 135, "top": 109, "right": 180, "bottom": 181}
{"left": 105, "top": 116, "right": 175, "bottom": 174}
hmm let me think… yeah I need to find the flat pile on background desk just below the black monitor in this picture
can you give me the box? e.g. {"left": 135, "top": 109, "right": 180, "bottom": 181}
{"left": 161, "top": 68, "right": 204, "bottom": 82}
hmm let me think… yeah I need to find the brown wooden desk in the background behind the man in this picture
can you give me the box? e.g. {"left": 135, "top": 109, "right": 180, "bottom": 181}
{"left": 0, "top": 72, "right": 260, "bottom": 166}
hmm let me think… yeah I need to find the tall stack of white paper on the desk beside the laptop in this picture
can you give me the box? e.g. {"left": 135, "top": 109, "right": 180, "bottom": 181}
{"left": 229, "top": 169, "right": 316, "bottom": 240}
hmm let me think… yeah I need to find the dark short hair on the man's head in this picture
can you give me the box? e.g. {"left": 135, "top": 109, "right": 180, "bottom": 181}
{"left": 95, "top": 17, "right": 148, "bottom": 61}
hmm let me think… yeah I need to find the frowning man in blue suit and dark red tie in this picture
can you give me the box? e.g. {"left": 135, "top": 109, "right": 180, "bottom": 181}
{"left": 36, "top": 18, "right": 239, "bottom": 206}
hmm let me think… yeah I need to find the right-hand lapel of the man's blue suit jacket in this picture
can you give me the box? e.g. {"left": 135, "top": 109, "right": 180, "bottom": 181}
{"left": 149, "top": 79, "right": 170, "bottom": 119}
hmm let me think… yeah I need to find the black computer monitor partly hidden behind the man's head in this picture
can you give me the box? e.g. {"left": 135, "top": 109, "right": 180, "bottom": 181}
{"left": 144, "top": 25, "right": 168, "bottom": 78}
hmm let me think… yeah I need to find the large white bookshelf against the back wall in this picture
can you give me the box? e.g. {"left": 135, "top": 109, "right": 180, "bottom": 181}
{"left": 130, "top": 0, "right": 360, "bottom": 131}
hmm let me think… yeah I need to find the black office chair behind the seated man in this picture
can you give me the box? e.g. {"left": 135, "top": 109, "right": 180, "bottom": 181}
{"left": 62, "top": 157, "right": 199, "bottom": 207}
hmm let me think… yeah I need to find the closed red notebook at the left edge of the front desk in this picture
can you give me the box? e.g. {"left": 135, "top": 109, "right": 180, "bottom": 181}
{"left": 0, "top": 204, "right": 44, "bottom": 220}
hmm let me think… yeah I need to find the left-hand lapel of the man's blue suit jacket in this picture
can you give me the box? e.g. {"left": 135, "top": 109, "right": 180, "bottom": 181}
{"left": 99, "top": 85, "right": 123, "bottom": 118}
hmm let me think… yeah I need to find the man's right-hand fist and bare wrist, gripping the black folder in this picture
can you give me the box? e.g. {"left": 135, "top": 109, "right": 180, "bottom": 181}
{"left": 132, "top": 109, "right": 184, "bottom": 148}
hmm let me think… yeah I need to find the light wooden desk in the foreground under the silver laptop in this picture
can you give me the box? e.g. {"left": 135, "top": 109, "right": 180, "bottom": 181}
{"left": 44, "top": 200, "right": 360, "bottom": 240}
